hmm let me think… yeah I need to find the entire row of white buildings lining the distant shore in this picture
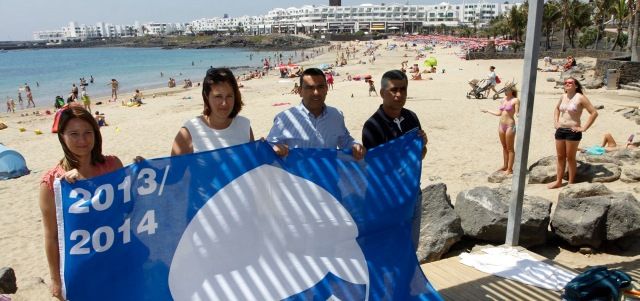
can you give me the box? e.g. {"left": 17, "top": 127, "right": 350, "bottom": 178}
{"left": 33, "top": 0, "right": 521, "bottom": 43}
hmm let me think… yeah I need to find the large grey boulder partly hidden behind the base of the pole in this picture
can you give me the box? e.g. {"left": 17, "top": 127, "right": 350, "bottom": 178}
{"left": 454, "top": 187, "right": 551, "bottom": 246}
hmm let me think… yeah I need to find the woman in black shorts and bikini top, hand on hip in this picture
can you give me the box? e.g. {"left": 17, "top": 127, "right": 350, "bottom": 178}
{"left": 547, "top": 77, "right": 598, "bottom": 189}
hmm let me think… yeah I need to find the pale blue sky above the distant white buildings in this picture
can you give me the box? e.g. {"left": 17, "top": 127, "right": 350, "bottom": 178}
{"left": 0, "top": 0, "right": 470, "bottom": 41}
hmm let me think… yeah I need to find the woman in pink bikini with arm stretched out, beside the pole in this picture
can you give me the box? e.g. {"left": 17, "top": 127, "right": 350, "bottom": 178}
{"left": 482, "top": 86, "right": 520, "bottom": 174}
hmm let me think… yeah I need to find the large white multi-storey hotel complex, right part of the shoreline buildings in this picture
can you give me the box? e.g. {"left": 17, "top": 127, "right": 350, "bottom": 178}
{"left": 208, "top": 1, "right": 521, "bottom": 34}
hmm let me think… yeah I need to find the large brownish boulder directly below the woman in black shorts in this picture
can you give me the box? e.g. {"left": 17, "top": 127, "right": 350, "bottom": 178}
{"left": 551, "top": 195, "right": 610, "bottom": 248}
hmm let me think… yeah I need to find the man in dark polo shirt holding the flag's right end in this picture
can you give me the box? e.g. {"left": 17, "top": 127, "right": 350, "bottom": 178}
{"left": 362, "top": 70, "right": 429, "bottom": 248}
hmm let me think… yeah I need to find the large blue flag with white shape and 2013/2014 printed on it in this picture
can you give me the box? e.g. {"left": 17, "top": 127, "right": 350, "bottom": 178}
{"left": 55, "top": 132, "right": 441, "bottom": 301}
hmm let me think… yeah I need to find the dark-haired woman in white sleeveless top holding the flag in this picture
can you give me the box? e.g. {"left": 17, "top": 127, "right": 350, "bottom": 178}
{"left": 171, "top": 68, "right": 253, "bottom": 156}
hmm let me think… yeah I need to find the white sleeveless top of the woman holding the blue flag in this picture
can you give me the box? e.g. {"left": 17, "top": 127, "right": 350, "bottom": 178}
{"left": 182, "top": 116, "right": 251, "bottom": 153}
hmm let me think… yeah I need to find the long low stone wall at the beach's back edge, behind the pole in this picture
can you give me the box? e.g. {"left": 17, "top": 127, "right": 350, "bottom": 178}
{"left": 467, "top": 49, "right": 629, "bottom": 60}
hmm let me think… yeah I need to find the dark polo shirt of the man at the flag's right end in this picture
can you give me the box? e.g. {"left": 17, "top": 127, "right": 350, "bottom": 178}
{"left": 362, "top": 105, "right": 422, "bottom": 150}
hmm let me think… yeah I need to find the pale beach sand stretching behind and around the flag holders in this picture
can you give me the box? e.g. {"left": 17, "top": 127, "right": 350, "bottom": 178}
{"left": 0, "top": 41, "right": 640, "bottom": 300}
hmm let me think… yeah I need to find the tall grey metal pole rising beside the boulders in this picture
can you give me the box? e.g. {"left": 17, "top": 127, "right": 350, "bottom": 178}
{"left": 505, "top": 0, "right": 544, "bottom": 246}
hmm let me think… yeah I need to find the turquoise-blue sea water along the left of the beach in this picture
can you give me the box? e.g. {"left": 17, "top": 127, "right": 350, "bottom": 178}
{"left": 0, "top": 48, "right": 301, "bottom": 108}
